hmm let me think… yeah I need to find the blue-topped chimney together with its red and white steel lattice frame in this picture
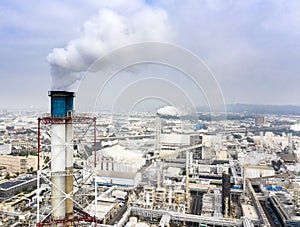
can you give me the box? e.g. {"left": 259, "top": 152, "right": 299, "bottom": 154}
{"left": 37, "top": 91, "right": 97, "bottom": 227}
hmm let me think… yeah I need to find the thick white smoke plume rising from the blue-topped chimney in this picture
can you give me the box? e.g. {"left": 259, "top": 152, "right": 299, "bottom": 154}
{"left": 47, "top": 1, "right": 171, "bottom": 90}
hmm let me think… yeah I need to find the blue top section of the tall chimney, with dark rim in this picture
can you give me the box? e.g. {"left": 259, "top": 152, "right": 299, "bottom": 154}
{"left": 48, "top": 91, "right": 75, "bottom": 118}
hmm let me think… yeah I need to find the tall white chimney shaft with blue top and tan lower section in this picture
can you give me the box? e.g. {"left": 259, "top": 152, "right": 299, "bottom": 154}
{"left": 49, "top": 91, "right": 75, "bottom": 220}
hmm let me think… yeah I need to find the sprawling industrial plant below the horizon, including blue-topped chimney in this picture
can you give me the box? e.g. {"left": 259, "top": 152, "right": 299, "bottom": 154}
{"left": 0, "top": 91, "right": 300, "bottom": 227}
